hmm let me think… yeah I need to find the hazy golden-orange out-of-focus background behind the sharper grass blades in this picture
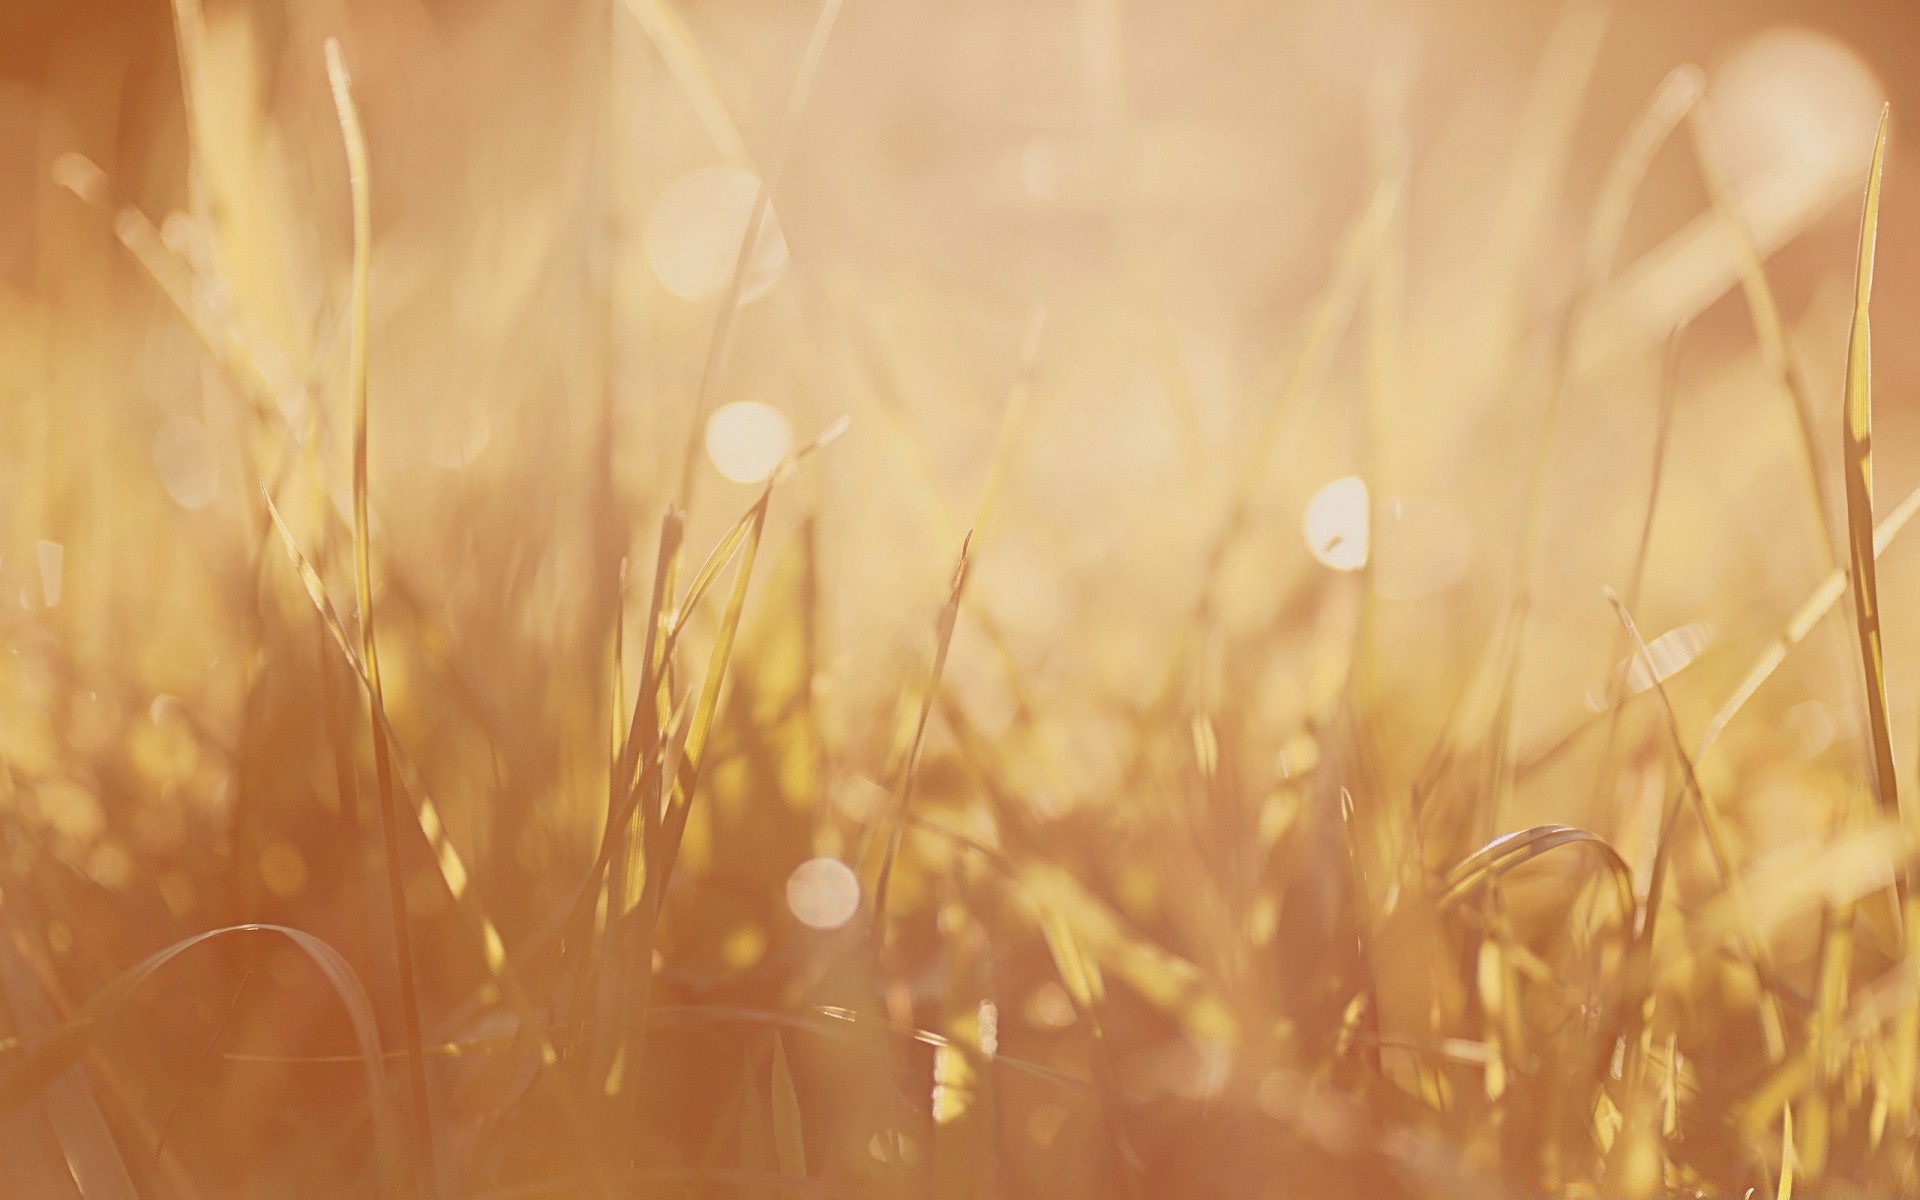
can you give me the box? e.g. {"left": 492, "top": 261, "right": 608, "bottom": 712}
{"left": 0, "top": 0, "right": 1920, "bottom": 1196}
